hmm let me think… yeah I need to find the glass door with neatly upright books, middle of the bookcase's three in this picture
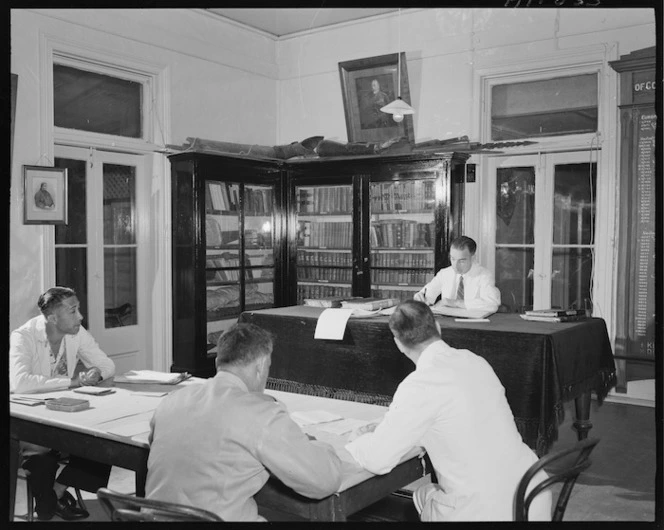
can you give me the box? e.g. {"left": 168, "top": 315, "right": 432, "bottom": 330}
{"left": 295, "top": 184, "right": 353, "bottom": 304}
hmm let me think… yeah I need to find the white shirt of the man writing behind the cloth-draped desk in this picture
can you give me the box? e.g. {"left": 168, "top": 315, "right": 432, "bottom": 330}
{"left": 417, "top": 263, "right": 500, "bottom": 313}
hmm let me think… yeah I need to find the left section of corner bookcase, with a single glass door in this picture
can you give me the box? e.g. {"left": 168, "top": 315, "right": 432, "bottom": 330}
{"left": 170, "top": 153, "right": 284, "bottom": 376}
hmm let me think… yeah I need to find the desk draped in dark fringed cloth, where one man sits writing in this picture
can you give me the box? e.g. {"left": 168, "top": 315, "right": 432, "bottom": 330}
{"left": 240, "top": 306, "right": 615, "bottom": 456}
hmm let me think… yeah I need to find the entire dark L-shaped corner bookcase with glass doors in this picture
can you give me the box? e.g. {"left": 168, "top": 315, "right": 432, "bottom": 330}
{"left": 169, "top": 152, "right": 467, "bottom": 377}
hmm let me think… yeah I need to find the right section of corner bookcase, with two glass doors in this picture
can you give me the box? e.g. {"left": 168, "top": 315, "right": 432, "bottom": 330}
{"left": 288, "top": 153, "right": 467, "bottom": 305}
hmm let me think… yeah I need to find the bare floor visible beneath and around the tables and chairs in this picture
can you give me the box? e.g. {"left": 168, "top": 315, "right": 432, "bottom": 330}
{"left": 15, "top": 401, "right": 661, "bottom": 522}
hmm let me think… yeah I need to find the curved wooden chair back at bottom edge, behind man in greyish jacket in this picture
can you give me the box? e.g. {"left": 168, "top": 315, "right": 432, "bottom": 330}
{"left": 97, "top": 488, "right": 223, "bottom": 522}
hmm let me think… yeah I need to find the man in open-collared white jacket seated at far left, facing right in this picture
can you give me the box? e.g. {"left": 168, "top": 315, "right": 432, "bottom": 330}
{"left": 9, "top": 287, "right": 115, "bottom": 521}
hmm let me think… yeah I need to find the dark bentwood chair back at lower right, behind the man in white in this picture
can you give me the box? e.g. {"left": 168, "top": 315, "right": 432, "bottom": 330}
{"left": 514, "top": 438, "right": 599, "bottom": 521}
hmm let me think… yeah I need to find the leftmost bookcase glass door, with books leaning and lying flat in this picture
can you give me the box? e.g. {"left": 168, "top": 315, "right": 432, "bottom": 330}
{"left": 205, "top": 180, "right": 275, "bottom": 354}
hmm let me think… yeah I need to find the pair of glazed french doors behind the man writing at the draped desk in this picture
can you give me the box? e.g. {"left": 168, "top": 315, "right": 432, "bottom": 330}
{"left": 483, "top": 152, "right": 597, "bottom": 312}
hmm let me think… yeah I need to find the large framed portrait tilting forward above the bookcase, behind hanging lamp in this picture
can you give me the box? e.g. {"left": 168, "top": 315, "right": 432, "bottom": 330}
{"left": 339, "top": 52, "right": 415, "bottom": 143}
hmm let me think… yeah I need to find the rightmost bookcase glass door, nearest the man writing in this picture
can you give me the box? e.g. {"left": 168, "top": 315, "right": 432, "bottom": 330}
{"left": 369, "top": 175, "right": 436, "bottom": 300}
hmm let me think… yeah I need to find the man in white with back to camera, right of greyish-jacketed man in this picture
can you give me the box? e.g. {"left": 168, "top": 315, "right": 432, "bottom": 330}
{"left": 346, "top": 300, "right": 551, "bottom": 521}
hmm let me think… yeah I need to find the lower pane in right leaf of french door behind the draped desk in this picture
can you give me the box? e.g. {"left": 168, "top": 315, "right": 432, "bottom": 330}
{"left": 551, "top": 248, "right": 593, "bottom": 310}
